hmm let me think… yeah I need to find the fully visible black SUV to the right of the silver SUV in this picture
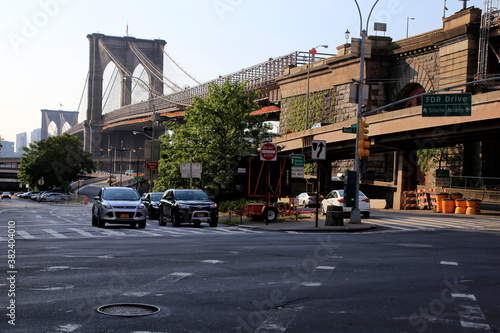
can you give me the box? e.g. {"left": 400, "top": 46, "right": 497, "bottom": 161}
{"left": 158, "top": 189, "right": 219, "bottom": 227}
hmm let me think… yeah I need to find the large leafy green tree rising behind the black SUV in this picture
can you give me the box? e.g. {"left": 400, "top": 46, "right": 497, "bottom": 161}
{"left": 156, "top": 80, "right": 270, "bottom": 190}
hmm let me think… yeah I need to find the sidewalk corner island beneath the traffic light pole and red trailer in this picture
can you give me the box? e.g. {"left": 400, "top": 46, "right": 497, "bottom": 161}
{"left": 220, "top": 214, "right": 377, "bottom": 232}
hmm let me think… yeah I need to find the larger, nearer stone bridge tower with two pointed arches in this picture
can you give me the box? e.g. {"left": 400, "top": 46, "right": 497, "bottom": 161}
{"left": 84, "top": 33, "right": 166, "bottom": 156}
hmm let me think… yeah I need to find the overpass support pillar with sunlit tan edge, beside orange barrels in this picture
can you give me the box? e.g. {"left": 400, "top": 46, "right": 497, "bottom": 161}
{"left": 393, "top": 149, "right": 418, "bottom": 210}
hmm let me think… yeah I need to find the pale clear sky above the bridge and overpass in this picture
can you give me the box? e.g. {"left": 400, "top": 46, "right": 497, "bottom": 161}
{"left": 0, "top": 0, "right": 483, "bottom": 142}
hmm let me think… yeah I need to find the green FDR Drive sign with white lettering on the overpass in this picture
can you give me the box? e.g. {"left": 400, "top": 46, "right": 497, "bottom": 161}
{"left": 422, "top": 93, "right": 472, "bottom": 117}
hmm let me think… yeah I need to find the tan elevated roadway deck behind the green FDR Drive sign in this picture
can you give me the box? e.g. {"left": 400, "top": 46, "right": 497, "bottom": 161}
{"left": 273, "top": 91, "right": 500, "bottom": 160}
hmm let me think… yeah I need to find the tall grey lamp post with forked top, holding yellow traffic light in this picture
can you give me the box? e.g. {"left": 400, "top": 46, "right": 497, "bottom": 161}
{"left": 349, "top": 0, "right": 379, "bottom": 224}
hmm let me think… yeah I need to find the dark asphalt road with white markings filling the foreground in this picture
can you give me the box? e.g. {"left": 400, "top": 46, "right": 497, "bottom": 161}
{"left": 0, "top": 199, "right": 500, "bottom": 332}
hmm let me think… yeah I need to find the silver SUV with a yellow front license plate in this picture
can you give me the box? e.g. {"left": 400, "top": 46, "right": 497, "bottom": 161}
{"left": 92, "top": 187, "right": 147, "bottom": 229}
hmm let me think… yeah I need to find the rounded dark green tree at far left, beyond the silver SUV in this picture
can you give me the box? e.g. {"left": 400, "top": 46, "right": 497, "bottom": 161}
{"left": 18, "top": 134, "right": 95, "bottom": 190}
